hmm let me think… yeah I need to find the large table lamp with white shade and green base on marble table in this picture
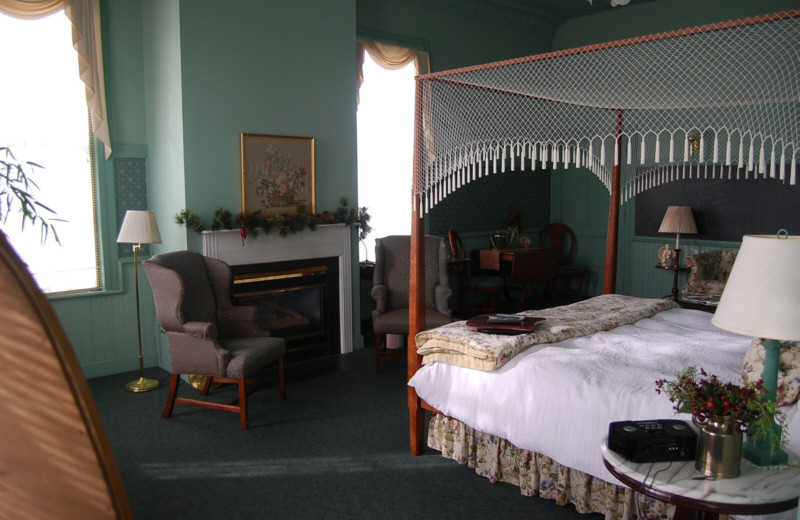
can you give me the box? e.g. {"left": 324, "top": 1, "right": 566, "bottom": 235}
{"left": 711, "top": 230, "right": 800, "bottom": 466}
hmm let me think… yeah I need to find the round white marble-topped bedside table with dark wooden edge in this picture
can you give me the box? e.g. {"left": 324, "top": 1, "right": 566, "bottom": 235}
{"left": 601, "top": 439, "right": 800, "bottom": 519}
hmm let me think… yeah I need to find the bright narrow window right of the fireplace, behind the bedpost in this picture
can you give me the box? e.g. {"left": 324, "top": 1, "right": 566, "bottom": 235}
{"left": 357, "top": 53, "right": 416, "bottom": 261}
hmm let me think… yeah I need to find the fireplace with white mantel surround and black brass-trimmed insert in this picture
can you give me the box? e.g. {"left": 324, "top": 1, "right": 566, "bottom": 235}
{"left": 202, "top": 224, "right": 353, "bottom": 357}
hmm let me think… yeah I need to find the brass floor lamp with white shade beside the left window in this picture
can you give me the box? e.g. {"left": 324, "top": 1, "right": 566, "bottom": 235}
{"left": 117, "top": 210, "right": 161, "bottom": 392}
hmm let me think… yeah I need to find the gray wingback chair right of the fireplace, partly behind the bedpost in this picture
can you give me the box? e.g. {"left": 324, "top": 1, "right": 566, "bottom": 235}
{"left": 371, "top": 235, "right": 452, "bottom": 372}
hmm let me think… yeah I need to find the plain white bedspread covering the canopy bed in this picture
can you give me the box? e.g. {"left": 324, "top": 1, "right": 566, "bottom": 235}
{"left": 409, "top": 309, "right": 800, "bottom": 492}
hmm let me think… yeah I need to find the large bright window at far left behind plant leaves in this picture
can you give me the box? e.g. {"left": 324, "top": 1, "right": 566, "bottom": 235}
{"left": 0, "top": 10, "right": 100, "bottom": 293}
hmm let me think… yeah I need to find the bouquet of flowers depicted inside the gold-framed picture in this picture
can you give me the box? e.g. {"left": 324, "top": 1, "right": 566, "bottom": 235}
{"left": 249, "top": 146, "right": 308, "bottom": 208}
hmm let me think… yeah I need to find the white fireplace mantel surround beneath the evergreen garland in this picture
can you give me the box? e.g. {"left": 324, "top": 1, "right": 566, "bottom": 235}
{"left": 202, "top": 224, "right": 353, "bottom": 354}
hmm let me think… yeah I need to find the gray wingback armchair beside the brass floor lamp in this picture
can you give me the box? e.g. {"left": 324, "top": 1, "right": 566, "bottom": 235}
{"left": 142, "top": 251, "right": 286, "bottom": 430}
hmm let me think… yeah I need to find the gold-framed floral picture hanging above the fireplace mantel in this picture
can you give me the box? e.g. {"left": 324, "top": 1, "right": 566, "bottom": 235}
{"left": 242, "top": 134, "right": 314, "bottom": 216}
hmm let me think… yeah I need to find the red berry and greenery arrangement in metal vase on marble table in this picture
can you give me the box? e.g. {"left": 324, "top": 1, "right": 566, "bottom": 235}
{"left": 656, "top": 366, "right": 785, "bottom": 453}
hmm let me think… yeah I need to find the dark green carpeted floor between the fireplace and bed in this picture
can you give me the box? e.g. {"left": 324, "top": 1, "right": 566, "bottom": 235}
{"left": 89, "top": 349, "right": 600, "bottom": 520}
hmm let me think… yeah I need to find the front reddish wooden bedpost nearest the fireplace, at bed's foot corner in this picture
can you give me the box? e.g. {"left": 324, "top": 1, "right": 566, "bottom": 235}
{"left": 407, "top": 77, "right": 425, "bottom": 455}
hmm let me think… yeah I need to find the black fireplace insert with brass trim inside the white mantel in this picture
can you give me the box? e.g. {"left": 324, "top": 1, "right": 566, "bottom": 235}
{"left": 231, "top": 257, "right": 340, "bottom": 362}
